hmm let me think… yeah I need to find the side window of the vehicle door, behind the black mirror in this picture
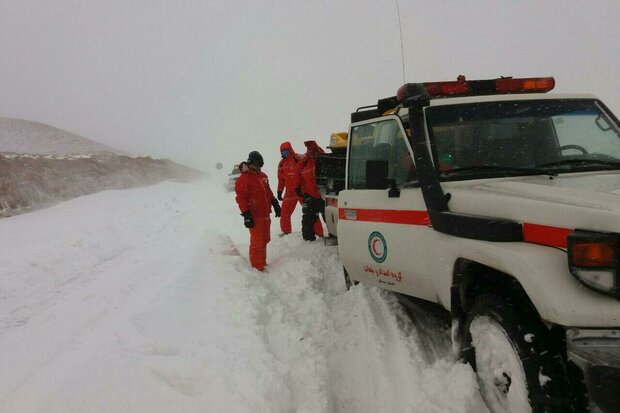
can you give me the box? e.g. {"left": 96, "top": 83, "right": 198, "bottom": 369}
{"left": 348, "top": 119, "right": 417, "bottom": 189}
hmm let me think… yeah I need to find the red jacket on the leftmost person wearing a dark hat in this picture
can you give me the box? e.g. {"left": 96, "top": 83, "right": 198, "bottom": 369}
{"left": 235, "top": 162, "right": 274, "bottom": 218}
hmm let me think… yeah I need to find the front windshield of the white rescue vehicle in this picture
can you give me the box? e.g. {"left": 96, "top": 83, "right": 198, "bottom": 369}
{"left": 426, "top": 99, "right": 620, "bottom": 180}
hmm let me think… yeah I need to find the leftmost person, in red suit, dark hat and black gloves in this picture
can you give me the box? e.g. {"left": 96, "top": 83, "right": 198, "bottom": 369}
{"left": 235, "top": 151, "right": 281, "bottom": 271}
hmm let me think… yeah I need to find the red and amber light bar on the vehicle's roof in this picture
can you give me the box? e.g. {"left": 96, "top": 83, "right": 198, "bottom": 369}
{"left": 396, "top": 75, "right": 555, "bottom": 102}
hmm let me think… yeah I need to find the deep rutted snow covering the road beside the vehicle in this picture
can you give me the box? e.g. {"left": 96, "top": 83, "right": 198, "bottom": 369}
{"left": 0, "top": 180, "right": 486, "bottom": 413}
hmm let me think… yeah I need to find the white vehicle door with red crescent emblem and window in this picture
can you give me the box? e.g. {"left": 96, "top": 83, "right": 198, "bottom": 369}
{"left": 338, "top": 115, "right": 435, "bottom": 299}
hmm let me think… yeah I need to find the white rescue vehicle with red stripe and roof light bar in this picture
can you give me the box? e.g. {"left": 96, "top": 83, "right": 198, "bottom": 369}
{"left": 326, "top": 76, "right": 620, "bottom": 413}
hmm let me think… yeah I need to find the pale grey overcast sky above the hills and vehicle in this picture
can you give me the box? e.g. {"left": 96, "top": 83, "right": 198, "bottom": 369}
{"left": 0, "top": 0, "right": 620, "bottom": 170}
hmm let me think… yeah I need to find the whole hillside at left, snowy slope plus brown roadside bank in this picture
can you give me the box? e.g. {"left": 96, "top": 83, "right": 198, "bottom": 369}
{"left": 0, "top": 118, "right": 202, "bottom": 218}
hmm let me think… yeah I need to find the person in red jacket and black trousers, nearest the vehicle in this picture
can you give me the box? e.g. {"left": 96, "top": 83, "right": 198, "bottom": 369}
{"left": 295, "top": 141, "right": 325, "bottom": 241}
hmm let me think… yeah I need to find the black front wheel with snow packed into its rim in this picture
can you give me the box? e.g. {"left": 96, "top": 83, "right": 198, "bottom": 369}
{"left": 463, "top": 295, "right": 586, "bottom": 413}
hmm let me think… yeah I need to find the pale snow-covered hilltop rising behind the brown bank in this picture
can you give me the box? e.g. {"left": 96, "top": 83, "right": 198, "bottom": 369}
{"left": 0, "top": 118, "right": 123, "bottom": 155}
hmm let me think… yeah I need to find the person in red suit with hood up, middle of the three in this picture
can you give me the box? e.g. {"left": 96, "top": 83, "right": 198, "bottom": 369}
{"left": 278, "top": 142, "right": 301, "bottom": 234}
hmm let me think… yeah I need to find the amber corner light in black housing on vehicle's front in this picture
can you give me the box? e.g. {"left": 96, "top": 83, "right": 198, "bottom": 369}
{"left": 568, "top": 230, "right": 620, "bottom": 299}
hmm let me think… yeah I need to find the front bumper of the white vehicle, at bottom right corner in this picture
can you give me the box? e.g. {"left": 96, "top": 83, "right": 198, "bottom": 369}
{"left": 566, "top": 328, "right": 620, "bottom": 413}
